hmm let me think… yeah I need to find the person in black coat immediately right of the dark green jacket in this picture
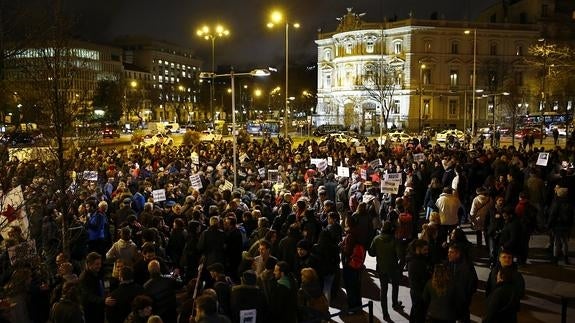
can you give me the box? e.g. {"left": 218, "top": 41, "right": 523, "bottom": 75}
{"left": 407, "top": 239, "right": 431, "bottom": 323}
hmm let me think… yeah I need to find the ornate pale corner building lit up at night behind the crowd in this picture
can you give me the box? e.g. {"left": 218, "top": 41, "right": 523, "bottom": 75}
{"left": 314, "top": 0, "right": 575, "bottom": 131}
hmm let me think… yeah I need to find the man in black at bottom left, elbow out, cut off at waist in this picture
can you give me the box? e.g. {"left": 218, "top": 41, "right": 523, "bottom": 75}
{"left": 105, "top": 267, "right": 145, "bottom": 323}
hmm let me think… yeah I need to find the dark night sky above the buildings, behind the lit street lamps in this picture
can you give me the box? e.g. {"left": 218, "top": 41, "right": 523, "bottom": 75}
{"left": 56, "top": 0, "right": 498, "bottom": 69}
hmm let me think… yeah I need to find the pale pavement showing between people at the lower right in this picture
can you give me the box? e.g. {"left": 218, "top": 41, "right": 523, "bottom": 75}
{"left": 330, "top": 234, "right": 575, "bottom": 323}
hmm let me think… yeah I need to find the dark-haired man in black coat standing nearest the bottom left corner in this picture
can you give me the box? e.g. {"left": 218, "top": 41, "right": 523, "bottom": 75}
{"left": 79, "top": 252, "right": 105, "bottom": 323}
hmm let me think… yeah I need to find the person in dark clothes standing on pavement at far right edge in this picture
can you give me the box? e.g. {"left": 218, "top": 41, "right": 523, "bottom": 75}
{"left": 547, "top": 185, "right": 574, "bottom": 265}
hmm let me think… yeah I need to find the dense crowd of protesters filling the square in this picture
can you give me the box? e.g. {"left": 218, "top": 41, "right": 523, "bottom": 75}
{"left": 0, "top": 131, "right": 575, "bottom": 323}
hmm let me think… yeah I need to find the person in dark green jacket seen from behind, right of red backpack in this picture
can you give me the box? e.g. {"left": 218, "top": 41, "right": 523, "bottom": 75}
{"left": 369, "top": 221, "right": 403, "bottom": 321}
